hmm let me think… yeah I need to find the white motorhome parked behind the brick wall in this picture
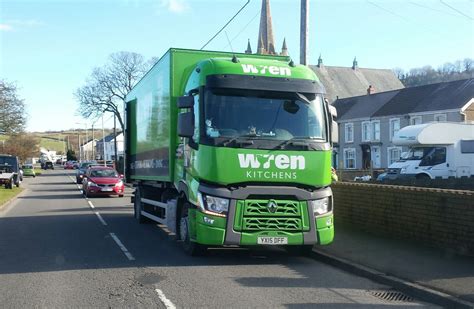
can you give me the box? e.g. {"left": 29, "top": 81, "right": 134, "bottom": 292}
{"left": 387, "top": 122, "right": 474, "bottom": 179}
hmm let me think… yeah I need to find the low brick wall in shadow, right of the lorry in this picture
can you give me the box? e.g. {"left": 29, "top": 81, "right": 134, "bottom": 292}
{"left": 332, "top": 182, "right": 474, "bottom": 255}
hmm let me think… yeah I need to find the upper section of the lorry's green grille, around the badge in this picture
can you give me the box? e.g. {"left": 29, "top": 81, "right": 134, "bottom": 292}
{"left": 244, "top": 200, "right": 301, "bottom": 216}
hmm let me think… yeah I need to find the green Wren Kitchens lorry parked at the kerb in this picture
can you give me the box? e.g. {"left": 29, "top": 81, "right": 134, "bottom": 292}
{"left": 125, "top": 49, "right": 337, "bottom": 255}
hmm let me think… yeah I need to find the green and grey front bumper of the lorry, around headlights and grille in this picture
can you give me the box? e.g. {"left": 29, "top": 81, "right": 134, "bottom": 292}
{"left": 191, "top": 185, "right": 334, "bottom": 246}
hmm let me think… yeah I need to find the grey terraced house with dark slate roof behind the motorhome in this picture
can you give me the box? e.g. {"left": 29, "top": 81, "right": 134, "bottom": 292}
{"left": 333, "top": 79, "right": 474, "bottom": 169}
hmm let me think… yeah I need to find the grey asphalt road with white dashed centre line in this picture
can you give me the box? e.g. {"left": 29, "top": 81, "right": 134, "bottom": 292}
{"left": 0, "top": 170, "right": 433, "bottom": 308}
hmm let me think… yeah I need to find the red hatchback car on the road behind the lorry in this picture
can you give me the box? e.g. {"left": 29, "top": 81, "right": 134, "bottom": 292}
{"left": 82, "top": 166, "right": 125, "bottom": 197}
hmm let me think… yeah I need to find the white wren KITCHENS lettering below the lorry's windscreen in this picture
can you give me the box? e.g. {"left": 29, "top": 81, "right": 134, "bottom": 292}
{"left": 238, "top": 153, "right": 306, "bottom": 180}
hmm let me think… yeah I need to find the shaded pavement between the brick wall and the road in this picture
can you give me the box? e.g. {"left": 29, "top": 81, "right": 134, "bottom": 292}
{"left": 315, "top": 225, "right": 474, "bottom": 308}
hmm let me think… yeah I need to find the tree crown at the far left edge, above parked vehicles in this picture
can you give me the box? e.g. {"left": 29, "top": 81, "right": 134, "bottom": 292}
{"left": 0, "top": 80, "right": 26, "bottom": 134}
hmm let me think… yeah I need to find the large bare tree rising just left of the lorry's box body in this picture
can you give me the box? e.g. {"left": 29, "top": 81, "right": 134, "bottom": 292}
{"left": 75, "top": 51, "right": 150, "bottom": 131}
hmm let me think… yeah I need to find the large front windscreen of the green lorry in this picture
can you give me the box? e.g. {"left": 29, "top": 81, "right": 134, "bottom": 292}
{"left": 202, "top": 90, "right": 326, "bottom": 141}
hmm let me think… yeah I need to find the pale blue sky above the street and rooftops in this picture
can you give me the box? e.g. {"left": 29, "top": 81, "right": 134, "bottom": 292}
{"left": 0, "top": 0, "right": 474, "bottom": 131}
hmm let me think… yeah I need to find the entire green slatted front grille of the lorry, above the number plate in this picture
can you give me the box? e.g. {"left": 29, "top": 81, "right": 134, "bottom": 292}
{"left": 241, "top": 199, "right": 305, "bottom": 232}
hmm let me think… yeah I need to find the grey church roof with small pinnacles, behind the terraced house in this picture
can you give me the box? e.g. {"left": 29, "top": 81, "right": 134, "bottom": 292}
{"left": 309, "top": 55, "right": 404, "bottom": 103}
